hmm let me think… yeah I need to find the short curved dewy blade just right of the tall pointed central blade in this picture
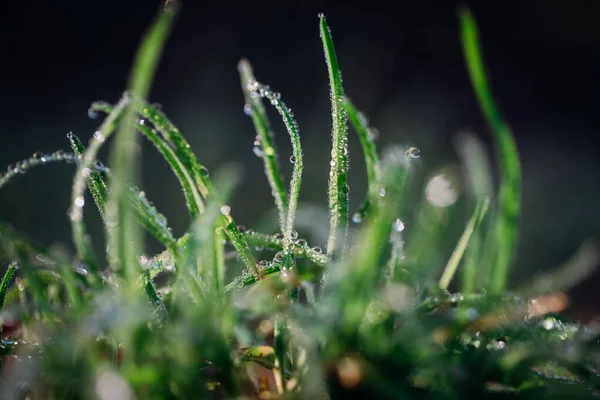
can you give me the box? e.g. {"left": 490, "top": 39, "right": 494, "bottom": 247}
{"left": 342, "top": 97, "right": 379, "bottom": 222}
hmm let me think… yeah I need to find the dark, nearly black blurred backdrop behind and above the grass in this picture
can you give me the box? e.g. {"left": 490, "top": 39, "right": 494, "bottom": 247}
{"left": 0, "top": 0, "right": 600, "bottom": 313}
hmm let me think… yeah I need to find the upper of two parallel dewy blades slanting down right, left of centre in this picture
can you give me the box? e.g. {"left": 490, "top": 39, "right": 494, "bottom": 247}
{"left": 138, "top": 104, "right": 259, "bottom": 274}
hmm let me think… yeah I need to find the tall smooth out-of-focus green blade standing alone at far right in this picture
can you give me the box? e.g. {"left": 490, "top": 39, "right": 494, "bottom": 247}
{"left": 459, "top": 8, "right": 521, "bottom": 292}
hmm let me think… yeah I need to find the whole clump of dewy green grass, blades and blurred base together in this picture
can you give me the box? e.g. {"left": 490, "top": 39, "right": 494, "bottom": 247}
{"left": 0, "top": 1, "right": 600, "bottom": 399}
